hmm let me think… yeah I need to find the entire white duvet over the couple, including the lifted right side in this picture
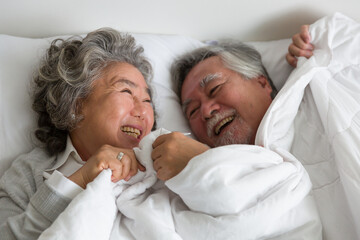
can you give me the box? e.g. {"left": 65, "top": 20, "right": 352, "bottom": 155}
{"left": 40, "top": 14, "right": 360, "bottom": 240}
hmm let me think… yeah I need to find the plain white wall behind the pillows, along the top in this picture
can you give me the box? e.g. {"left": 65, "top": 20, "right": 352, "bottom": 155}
{"left": 0, "top": 0, "right": 360, "bottom": 41}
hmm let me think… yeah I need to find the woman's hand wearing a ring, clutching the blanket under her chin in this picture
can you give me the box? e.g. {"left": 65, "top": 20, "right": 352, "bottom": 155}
{"left": 69, "top": 145, "right": 145, "bottom": 188}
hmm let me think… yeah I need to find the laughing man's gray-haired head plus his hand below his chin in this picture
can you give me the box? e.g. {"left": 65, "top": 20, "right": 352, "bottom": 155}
{"left": 153, "top": 43, "right": 277, "bottom": 180}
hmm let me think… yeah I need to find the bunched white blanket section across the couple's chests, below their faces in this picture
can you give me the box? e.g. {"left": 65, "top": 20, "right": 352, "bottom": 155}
{"left": 40, "top": 126, "right": 321, "bottom": 240}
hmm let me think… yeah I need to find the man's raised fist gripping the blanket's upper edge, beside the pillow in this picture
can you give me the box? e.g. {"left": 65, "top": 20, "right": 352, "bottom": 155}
{"left": 286, "top": 25, "right": 314, "bottom": 67}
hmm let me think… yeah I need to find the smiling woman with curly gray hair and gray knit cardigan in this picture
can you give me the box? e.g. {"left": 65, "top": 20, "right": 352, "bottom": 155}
{"left": 0, "top": 29, "right": 154, "bottom": 239}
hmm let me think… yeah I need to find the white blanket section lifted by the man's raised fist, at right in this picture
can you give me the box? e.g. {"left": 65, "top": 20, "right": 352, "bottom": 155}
{"left": 256, "top": 14, "right": 360, "bottom": 240}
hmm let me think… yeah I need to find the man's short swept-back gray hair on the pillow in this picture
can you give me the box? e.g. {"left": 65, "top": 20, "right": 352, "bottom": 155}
{"left": 171, "top": 41, "right": 277, "bottom": 98}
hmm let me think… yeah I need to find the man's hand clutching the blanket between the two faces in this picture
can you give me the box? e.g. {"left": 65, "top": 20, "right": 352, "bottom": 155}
{"left": 151, "top": 132, "right": 210, "bottom": 181}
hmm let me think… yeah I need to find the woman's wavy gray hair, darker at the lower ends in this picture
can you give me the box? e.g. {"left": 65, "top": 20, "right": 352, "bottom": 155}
{"left": 32, "top": 28, "right": 153, "bottom": 155}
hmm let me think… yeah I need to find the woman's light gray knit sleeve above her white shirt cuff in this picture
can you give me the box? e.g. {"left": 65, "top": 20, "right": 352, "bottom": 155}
{"left": 0, "top": 151, "right": 71, "bottom": 239}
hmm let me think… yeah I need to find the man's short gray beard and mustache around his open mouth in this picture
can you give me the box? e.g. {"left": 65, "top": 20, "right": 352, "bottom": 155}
{"left": 207, "top": 109, "right": 253, "bottom": 147}
